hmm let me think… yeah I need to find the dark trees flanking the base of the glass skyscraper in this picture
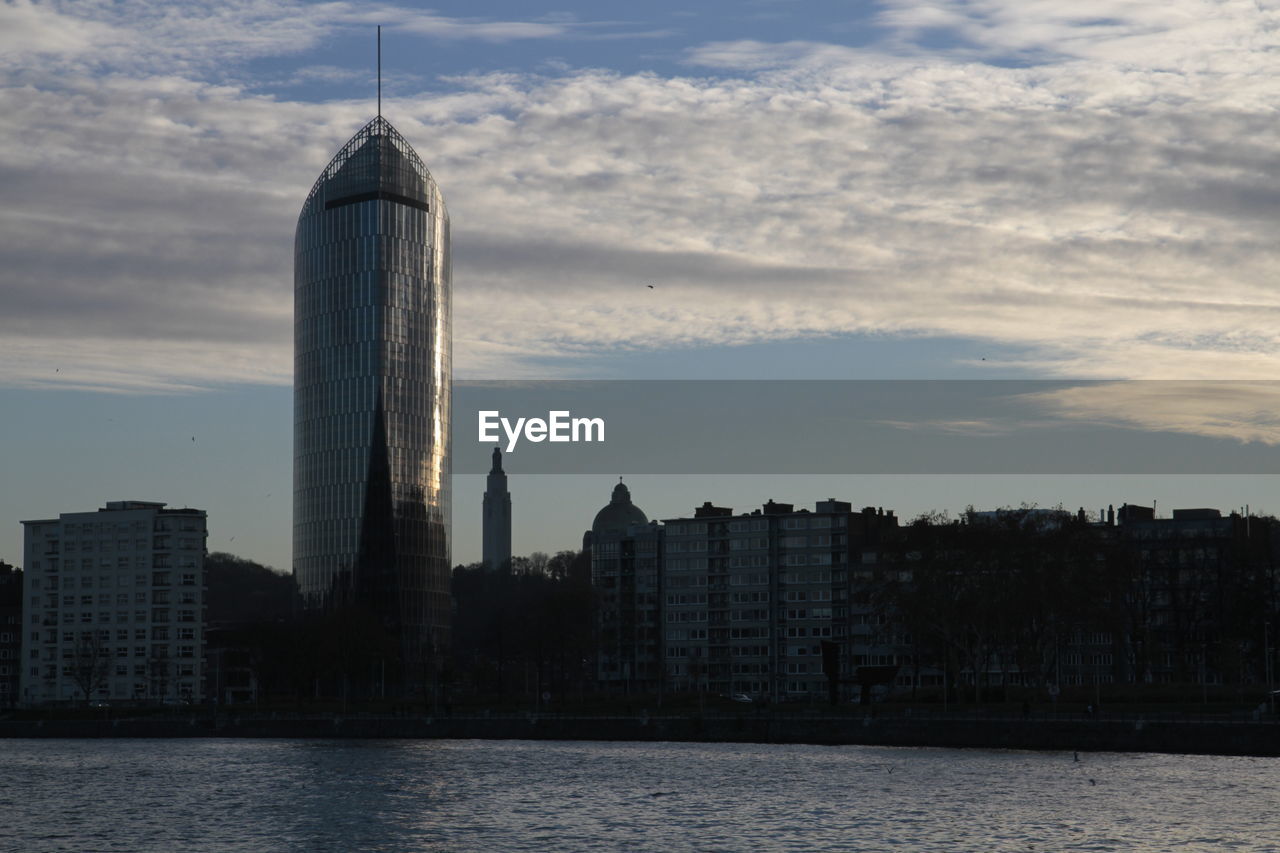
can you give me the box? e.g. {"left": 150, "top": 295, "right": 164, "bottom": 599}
{"left": 205, "top": 551, "right": 594, "bottom": 707}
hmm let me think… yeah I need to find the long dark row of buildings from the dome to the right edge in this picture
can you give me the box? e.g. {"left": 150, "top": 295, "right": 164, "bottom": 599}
{"left": 585, "top": 484, "right": 1280, "bottom": 702}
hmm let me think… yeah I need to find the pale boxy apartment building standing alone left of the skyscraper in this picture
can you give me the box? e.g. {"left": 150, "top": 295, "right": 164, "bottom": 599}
{"left": 19, "top": 501, "right": 206, "bottom": 706}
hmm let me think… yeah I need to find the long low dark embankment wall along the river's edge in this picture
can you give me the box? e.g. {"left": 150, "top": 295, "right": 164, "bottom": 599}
{"left": 0, "top": 713, "right": 1280, "bottom": 756}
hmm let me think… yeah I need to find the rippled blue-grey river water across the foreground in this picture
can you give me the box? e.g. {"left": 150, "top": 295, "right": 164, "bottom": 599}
{"left": 0, "top": 739, "right": 1280, "bottom": 853}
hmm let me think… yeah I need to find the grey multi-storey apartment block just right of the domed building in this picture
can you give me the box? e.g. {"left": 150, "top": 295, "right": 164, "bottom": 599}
{"left": 660, "top": 500, "right": 899, "bottom": 701}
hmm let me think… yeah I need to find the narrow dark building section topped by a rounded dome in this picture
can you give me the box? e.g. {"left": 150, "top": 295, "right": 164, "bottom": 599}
{"left": 582, "top": 479, "right": 662, "bottom": 693}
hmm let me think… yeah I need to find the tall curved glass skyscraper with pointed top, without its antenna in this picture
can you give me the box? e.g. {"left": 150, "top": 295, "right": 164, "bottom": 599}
{"left": 293, "top": 115, "right": 452, "bottom": 665}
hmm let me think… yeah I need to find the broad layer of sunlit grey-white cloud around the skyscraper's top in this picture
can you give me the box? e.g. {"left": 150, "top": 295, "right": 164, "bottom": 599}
{"left": 0, "top": 0, "right": 1280, "bottom": 384}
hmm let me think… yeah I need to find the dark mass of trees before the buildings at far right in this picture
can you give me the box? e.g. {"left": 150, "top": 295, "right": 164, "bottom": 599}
{"left": 880, "top": 507, "right": 1280, "bottom": 701}
